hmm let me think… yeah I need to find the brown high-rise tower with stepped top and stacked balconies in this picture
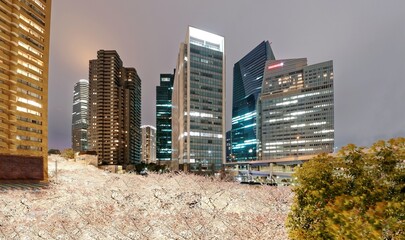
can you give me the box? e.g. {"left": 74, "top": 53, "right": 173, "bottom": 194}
{"left": 89, "top": 50, "right": 141, "bottom": 167}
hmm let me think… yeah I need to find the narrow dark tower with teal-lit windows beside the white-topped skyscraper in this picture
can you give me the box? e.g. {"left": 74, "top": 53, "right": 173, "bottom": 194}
{"left": 156, "top": 71, "right": 175, "bottom": 161}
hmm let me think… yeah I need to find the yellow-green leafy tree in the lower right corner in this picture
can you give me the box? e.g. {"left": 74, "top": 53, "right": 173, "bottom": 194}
{"left": 287, "top": 138, "right": 405, "bottom": 239}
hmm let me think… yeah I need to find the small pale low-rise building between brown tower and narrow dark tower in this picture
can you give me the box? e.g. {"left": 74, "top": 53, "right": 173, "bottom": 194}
{"left": 141, "top": 125, "right": 156, "bottom": 164}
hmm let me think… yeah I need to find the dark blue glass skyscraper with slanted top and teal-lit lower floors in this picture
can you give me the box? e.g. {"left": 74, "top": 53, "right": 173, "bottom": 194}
{"left": 231, "top": 41, "right": 275, "bottom": 161}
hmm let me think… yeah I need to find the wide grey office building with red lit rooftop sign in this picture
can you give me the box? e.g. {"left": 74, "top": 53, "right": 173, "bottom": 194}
{"left": 258, "top": 58, "right": 334, "bottom": 160}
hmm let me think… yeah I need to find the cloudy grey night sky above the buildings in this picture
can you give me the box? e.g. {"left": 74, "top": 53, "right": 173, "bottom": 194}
{"left": 49, "top": 0, "right": 405, "bottom": 149}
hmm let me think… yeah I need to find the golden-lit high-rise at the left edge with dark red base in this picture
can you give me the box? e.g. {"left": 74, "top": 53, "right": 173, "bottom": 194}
{"left": 0, "top": 0, "right": 52, "bottom": 181}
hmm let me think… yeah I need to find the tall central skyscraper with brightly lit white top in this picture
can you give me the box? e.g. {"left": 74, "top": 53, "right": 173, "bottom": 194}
{"left": 172, "top": 27, "right": 225, "bottom": 172}
